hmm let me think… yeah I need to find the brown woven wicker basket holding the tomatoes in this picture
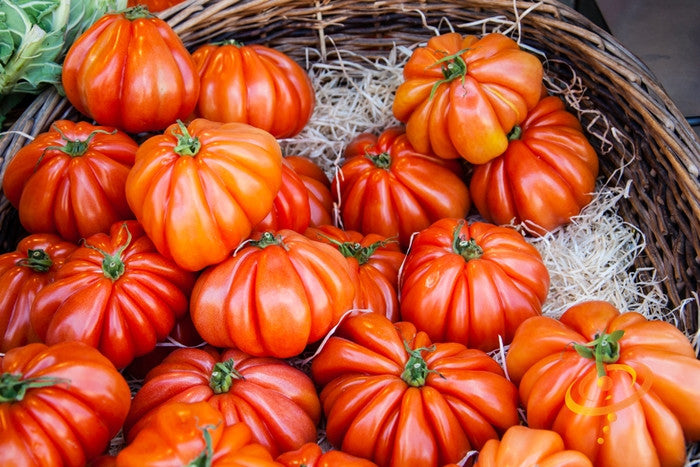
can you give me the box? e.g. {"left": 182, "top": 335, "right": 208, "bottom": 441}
{"left": 0, "top": 0, "right": 700, "bottom": 460}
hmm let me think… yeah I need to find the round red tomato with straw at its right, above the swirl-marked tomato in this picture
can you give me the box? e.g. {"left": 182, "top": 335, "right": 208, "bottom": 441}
{"left": 399, "top": 218, "right": 549, "bottom": 351}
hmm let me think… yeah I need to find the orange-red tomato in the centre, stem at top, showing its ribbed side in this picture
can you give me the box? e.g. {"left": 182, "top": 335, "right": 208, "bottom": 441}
{"left": 190, "top": 230, "right": 357, "bottom": 358}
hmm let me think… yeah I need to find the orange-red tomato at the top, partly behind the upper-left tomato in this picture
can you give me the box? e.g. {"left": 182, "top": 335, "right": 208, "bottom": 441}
{"left": 192, "top": 40, "right": 316, "bottom": 138}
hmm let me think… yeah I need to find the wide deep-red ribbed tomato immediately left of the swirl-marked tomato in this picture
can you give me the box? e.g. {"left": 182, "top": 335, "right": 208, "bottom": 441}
{"left": 311, "top": 313, "right": 518, "bottom": 466}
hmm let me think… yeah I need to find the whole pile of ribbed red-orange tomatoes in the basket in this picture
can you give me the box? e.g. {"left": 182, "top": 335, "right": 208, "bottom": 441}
{"left": 0, "top": 7, "right": 700, "bottom": 466}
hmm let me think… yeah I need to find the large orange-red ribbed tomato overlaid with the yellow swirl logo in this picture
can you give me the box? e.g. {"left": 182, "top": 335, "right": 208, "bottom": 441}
{"left": 506, "top": 301, "right": 700, "bottom": 467}
